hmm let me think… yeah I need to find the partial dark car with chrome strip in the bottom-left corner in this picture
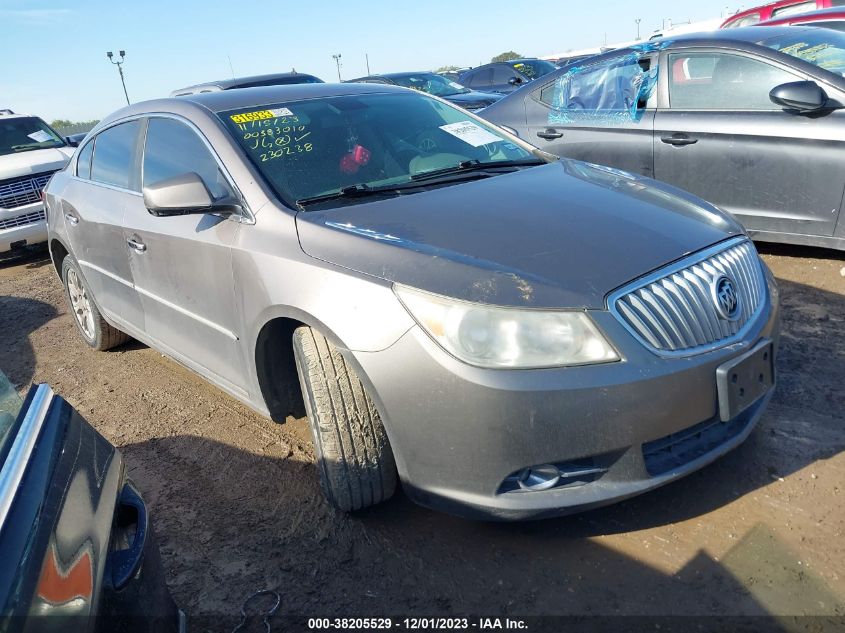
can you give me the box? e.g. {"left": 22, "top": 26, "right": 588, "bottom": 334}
{"left": 0, "top": 373, "right": 184, "bottom": 633}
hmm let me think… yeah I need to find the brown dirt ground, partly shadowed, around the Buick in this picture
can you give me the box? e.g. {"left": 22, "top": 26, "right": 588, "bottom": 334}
{"left": 0, "top": 245, "right": 845, "bottom": 630}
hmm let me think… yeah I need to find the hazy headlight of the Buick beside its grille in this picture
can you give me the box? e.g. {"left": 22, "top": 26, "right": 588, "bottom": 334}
{"left": 394, "top": 286, "right": 619, "bottom": 369}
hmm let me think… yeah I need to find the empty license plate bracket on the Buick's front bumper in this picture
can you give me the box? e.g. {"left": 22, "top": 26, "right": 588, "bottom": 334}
{"left": 716, "top": 339, "right": 775, "bottom": 422}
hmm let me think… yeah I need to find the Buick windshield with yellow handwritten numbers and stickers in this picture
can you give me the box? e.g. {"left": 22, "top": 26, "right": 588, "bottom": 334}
{"left": 218, "top": 92, "right": 538, "bottom": 206}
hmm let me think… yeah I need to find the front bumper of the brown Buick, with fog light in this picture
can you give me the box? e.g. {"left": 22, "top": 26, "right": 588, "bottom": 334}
{"left": 353, "top": 266, "right": 779, "bottom": 519}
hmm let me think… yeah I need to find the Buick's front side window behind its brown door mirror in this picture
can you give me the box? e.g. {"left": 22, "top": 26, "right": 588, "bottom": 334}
{"left": 142, "top": 118, "right": 232, "bottom": 200}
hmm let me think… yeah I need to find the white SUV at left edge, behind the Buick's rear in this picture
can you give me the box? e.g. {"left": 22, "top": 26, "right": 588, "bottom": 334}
{"left": 0, "top": 110, "right": 73, "bottom": 254}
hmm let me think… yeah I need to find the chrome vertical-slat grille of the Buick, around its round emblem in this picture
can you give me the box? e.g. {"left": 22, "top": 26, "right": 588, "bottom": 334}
{"left": 608, "top": 240, "right": 766, "bottom": 356}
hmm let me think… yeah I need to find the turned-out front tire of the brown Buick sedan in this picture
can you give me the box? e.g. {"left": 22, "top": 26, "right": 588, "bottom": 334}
{"left": 293, "top": 327, "right": 397, "bottom": 512}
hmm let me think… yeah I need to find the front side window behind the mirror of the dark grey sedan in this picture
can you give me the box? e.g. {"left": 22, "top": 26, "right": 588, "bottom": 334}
{"left": 669, "top": 53, "right": 802, "bottom": 110}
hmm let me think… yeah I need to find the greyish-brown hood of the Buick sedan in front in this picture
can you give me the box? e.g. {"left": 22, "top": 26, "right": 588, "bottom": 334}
{"left": 297, "top": 160, "right": 742, "bottom": 309}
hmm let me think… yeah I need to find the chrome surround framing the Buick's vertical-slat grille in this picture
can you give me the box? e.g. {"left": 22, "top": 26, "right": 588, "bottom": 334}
{"left": 607, "top": 236, "right": 771, "bottom": 358}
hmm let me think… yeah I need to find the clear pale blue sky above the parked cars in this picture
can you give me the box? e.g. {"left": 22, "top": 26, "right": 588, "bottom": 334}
{"left": 0, "top": 0, "right": 750, "bottom": 121}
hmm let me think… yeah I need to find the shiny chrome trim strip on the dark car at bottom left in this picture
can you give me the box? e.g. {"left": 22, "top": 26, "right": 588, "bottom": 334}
{"left": 0, "top": 384, "right": 53, "bottom": 534}
